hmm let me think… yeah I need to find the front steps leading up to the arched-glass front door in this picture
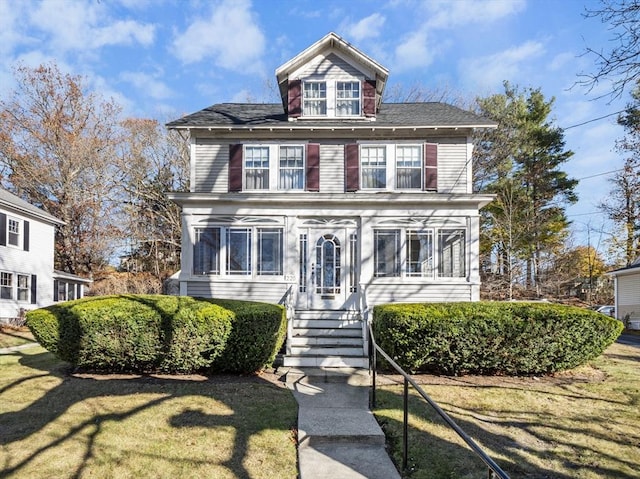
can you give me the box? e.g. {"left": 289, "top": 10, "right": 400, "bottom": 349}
{"left": 283, "top": 311, "right": 369, "bottom": 368}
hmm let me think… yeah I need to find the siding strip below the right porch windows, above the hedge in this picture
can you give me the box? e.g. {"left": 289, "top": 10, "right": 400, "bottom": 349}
{"left": 366, "top": 282, "right": 471, "bottom": 306}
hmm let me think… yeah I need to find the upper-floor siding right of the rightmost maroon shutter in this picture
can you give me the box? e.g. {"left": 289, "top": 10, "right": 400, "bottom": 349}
{"left": 438, "top": 139, "right": 471, "bottom": 193}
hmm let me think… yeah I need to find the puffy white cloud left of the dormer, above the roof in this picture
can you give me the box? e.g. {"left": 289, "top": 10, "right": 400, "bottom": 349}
{"left": 173, "top": 0, "right": 265, "bottom": 73}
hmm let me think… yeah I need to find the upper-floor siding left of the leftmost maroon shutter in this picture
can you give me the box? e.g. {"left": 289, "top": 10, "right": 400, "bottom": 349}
{"left": 192, "top": 140, "right": 229, "bottom": 193}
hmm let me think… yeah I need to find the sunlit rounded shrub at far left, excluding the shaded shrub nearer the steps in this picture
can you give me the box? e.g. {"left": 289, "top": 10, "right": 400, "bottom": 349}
{"left": 27, "top": 295, "right": 234, "bottom": 373}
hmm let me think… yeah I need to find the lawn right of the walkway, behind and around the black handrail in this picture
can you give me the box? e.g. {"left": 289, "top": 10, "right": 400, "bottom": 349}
{"left": 375, "top": 344, "right": 640, "bottom": 479}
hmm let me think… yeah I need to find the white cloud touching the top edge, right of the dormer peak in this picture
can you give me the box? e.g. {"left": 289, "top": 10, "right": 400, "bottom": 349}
{"left": 424, "top": 0, "right": 526, "bottom": 28}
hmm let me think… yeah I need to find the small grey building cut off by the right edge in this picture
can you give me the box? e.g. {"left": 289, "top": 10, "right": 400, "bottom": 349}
{"left": 607, "top": 257, "right": 640, "bottom": 329}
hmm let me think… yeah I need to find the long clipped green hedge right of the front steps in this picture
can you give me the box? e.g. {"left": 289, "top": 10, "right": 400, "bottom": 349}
{"left": 373, "top": 302, "right": 623, "bottom": 375}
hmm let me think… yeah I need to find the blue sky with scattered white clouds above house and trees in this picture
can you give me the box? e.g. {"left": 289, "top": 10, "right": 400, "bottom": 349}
{"left": 0, "top": 0, "right": 628, "bottom": 251}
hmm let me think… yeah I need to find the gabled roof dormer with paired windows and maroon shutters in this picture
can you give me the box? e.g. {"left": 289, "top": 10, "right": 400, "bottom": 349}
{"left": 276, "top": 33, "right": 389, "bottom": 121}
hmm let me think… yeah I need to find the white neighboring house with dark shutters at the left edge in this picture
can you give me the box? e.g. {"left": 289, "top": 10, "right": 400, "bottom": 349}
{"left": 0, "top": 189, "right": 91, "bottom": 322}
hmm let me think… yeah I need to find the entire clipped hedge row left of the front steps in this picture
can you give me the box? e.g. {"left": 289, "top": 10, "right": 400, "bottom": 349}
{"left": 27, "top": 295, "right": 286, "bottom": 373}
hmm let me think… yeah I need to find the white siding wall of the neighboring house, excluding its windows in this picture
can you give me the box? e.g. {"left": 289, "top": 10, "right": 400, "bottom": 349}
{"left": 0, "top": 210, "right": 54, "bottom": 318}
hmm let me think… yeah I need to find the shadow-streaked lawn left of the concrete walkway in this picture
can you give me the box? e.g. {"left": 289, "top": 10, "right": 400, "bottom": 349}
{"left": 0, "top": 347, "right": 297, "bottom": 479}
